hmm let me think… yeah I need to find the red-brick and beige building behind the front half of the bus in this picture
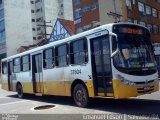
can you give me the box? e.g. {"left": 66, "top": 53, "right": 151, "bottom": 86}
{"left": 73, "top": 0, "right": 160, "bottom": 43}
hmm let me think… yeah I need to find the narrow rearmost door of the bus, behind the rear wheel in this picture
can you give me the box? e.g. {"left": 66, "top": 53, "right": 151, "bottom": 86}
{"left": 7, "top": 61, "right": 13, "bottom": 91}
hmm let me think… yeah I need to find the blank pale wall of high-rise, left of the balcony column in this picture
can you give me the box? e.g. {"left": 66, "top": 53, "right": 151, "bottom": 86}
{"left": 4, "top": 0, "right": 33, "bottom": 56}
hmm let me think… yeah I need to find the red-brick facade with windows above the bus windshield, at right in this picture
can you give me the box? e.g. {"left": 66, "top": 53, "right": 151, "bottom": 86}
{"left": 121, "top": 0, "right": 160, "bottom": 43}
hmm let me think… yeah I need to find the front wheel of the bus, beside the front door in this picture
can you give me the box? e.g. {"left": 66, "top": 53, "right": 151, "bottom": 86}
{"left": 73, "top": 84, "right": 88, "bottom": 107}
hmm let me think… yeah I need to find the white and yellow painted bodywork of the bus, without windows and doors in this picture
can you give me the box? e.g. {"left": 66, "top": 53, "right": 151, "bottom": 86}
{"left": 2, "top": 23, "right": 159, "bottom": 99}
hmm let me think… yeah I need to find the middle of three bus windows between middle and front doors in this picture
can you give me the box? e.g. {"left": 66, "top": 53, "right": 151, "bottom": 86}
{"left": 55, "top": 44, "right": 68, "bottom": 67}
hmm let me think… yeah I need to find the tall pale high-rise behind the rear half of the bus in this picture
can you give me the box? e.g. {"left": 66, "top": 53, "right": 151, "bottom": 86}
{"left": 0, "top": 0, "right": 73, "bottom": 58}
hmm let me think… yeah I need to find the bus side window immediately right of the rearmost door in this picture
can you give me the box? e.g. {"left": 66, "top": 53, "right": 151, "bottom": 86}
{"left": 13, "top": 58, "right": 21, "bottom": 73}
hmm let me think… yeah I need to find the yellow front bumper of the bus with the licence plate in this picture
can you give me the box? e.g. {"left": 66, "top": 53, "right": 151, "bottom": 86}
{"left": 113, "top": 80, "right": 159, "bottom": 99}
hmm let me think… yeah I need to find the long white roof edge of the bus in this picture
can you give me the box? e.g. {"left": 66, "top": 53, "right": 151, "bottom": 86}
{"left": 2, "top": 23, "right": 147, "bottom": 62}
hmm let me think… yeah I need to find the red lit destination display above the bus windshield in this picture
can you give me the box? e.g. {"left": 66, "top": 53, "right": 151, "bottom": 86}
{"left": 120, "top": 28, "right": 143, "bottom": 35}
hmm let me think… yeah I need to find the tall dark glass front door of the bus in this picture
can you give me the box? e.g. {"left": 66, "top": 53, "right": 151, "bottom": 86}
{"left": 90, "top": 34, "right": 113, "bottom": 97}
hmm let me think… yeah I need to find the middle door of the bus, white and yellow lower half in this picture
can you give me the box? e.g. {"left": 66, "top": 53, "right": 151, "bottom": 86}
{"left": 32, "top": 53, "right": 43, "bottom": 93}
